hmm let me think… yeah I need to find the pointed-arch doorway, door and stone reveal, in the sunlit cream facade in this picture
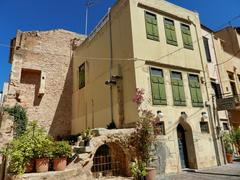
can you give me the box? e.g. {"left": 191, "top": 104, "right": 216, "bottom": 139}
{"left": 177, "top": 122, "right": 197, "bottom": 169}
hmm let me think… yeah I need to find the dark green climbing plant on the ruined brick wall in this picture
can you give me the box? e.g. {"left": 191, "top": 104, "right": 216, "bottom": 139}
{"left": 5, "top": 104, "right": 28, "bottom": 137}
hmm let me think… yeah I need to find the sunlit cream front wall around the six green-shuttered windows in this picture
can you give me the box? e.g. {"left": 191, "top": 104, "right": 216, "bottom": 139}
{"left": 131, "top": 0, "right": 216, "bottom": 173}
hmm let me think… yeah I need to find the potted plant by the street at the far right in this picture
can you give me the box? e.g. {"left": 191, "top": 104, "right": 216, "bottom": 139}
{"left": 223, "top": 133, "right": 234, "bottom": 163}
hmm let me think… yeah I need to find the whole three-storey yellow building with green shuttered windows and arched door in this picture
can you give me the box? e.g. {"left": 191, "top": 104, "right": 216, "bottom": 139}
{"left": 72, "top": 0, "right": 220, "bottom": 173}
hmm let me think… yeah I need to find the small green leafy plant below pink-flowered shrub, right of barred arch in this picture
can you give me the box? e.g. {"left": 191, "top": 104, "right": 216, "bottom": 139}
{"left": 130, "top": 159, "right": 147, "bottom": 180}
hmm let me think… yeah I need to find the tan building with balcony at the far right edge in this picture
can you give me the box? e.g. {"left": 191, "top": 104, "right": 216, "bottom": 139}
{"left": 215, "top": 27, "right": 240, "bottom": 128}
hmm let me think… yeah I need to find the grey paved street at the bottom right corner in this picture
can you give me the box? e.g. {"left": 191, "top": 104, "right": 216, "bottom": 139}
{"left": 158, "top": 162, "right": 240, "bottom": 180}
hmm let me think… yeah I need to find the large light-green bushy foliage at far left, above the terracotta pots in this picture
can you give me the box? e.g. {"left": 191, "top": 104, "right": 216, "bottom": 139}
{"left": 2, "top": 121, "right": 53, "bottom": 174}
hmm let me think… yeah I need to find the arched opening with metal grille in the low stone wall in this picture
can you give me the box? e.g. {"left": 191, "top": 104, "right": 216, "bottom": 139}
{"left": 91, "top": 142, "right": 129, "bottom": 177}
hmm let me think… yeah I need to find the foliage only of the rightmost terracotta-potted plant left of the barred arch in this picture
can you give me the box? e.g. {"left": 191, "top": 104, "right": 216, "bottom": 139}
{"left": 53, "top": 141, "right": 72, "bottom": 158}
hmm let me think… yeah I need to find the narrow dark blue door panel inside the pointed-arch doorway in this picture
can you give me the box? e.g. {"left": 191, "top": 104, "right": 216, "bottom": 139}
{"left": 177, "top": 124, "right": 189, "bottom": 169}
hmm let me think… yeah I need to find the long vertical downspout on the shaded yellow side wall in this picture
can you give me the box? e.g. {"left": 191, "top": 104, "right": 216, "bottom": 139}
{"left": 108, "top": 8, "right": 114, "bottom": 123}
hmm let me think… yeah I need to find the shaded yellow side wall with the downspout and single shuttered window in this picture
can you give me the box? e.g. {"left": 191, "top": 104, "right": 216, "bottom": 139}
{"left": 72, "top": 1, "right": 137, "bottom": 133}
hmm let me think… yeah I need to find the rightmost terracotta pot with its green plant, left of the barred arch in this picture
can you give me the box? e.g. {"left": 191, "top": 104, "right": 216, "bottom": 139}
{"left": 53, "top": 141, "right": 72, "bottom": 171}
